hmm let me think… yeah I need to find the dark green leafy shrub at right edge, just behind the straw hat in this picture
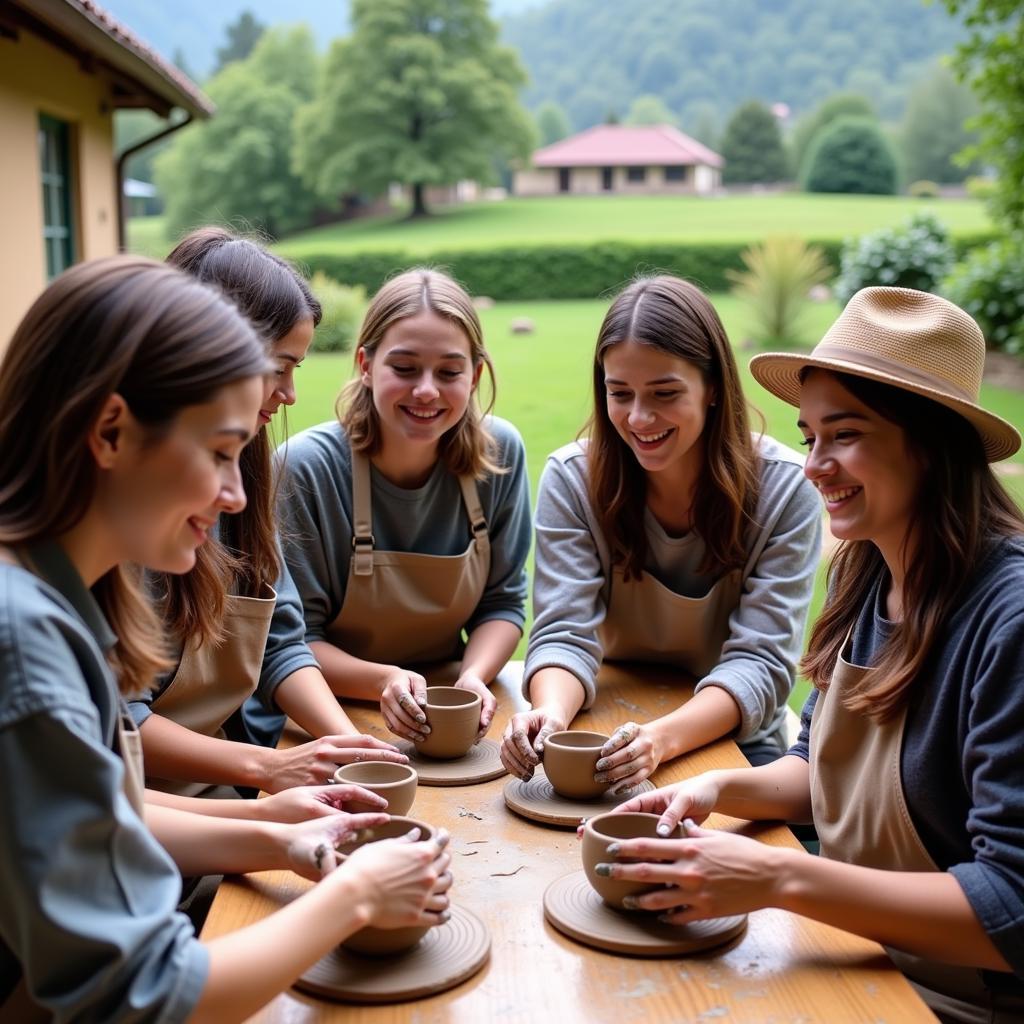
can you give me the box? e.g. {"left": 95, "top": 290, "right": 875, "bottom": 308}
{"left": 942, "top": 233, "right": 1024, "bottom": 355}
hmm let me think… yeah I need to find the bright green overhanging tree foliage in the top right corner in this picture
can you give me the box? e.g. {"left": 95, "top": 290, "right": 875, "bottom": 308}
{"left": 945, "top": 0, "right": 1024, "bottom": 230}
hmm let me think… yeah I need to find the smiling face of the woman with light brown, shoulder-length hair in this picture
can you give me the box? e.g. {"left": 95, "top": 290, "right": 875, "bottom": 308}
{"left": 357, "top": 309, "right": 482, "bottom": 446}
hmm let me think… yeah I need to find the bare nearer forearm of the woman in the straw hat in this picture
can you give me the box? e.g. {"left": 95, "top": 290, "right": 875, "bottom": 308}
{"left": 778, "top": 851, "right": 1011, "bottom": 971}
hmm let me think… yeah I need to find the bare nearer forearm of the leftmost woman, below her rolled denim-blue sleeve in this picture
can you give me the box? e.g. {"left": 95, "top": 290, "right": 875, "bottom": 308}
{"left": 190, "top": 868, "right": 369, "bottom": 1024}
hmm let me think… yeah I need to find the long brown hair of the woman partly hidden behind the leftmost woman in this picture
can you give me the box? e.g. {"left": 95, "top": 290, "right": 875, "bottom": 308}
{"left": 158, "top": 227, "right": 322, "bottom": 643}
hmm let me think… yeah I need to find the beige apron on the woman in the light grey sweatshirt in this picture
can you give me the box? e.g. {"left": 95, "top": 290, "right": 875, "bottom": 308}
{"left": 598, "top": 568, "right": 742, "bottom": 679}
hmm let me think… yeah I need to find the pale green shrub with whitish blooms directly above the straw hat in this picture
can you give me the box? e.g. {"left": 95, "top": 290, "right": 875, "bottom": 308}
{"left": 836, "top": 213, "right": 954, "bottom": 302}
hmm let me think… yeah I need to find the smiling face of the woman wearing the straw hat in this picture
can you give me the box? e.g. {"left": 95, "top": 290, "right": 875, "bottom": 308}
{"left": 799, "top": 370, "right": 924, "bottom": 561}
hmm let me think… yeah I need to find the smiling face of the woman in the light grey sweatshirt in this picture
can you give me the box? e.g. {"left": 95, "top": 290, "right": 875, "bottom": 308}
{"left": 604, "top": 341, "right": 714, "bottom": 473}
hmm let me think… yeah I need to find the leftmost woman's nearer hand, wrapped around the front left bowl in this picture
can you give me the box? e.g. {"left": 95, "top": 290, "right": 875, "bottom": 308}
{"left": 342, "top": 828, "right": 452, "bottom": 928}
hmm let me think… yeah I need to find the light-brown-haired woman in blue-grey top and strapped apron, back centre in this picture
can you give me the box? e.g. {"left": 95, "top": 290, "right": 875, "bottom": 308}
{"left": 280, "top": 269, "right": 530, "bottom": 739}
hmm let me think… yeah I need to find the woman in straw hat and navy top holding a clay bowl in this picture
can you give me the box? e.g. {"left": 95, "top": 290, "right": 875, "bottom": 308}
{"left": 602, "top": 288, "right": 1024, "bottom": 1022}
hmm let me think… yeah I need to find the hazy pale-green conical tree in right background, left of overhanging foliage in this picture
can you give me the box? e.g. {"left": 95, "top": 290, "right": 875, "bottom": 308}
{"left": 900, "top": 65, "right": 978, "bottom": 183}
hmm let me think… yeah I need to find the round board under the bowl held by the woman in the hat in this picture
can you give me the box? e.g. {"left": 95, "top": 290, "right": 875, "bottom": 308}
{"left": 544, "top": 871, "right": 746, "bottom": 956}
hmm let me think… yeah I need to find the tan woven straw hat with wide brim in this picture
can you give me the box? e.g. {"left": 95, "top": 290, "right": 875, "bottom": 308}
{"left": 751, "top": 288, "right": 1021, "bottom": 462}
